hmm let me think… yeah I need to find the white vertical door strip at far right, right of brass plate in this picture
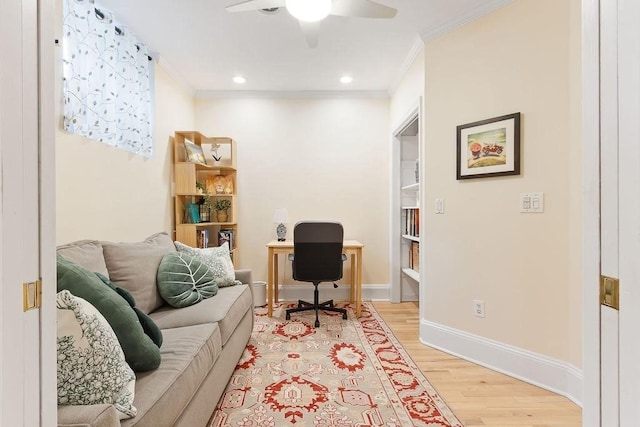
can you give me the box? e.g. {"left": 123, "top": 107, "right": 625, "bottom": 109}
{"left": 618, "top": 0, "right": 640, "bottom": 426}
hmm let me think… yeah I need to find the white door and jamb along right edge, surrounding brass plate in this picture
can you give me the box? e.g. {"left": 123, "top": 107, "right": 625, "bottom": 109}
{"left": 582, "top": 0, "right": 640, "bottom": 427}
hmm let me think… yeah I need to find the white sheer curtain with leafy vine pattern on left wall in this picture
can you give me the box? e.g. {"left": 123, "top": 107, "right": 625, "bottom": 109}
{"left": 63, "top": 0, "right": 153, "bottom": 157}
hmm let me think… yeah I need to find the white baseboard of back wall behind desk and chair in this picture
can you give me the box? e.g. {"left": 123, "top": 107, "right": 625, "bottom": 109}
{"left": 278, "top": 283, "right": 390, "bottom": 301}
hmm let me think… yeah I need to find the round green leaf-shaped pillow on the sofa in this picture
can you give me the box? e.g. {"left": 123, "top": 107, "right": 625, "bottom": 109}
{"left": 157, "top": 252, "right": 218, "bottom": 308}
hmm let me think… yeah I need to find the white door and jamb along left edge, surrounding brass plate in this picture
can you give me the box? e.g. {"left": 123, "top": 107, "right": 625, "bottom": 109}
{"left": 0, "top": 0, "right": 56, "bottom": 427}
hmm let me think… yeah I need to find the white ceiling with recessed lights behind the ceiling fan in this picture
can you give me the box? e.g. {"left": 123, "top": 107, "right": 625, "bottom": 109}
{"left": 97, "top": 0, "right": 511, "bottom": 95}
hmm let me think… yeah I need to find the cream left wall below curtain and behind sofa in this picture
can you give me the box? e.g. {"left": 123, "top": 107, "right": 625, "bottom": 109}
{"left": 56, "top": 66, "right": 194, "bottom": 244}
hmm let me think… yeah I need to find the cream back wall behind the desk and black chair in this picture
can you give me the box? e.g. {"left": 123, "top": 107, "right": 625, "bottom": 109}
{"left": 196, "top": 98, "right": 390, "bottom": 284}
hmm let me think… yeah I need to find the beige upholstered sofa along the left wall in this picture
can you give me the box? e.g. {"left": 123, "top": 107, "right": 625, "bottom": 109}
{"left": 58, "top": 233, "right": 253, "bottom": 427}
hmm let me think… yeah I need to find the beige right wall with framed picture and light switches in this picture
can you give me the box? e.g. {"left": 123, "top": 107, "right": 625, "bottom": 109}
{"left": 423, "top": 0, "right": 581, "bottom": 366}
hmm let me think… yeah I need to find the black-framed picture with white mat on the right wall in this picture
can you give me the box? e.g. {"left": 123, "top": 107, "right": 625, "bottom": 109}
{"left": 456, "top": 113, "right": 520, "bottom": 179}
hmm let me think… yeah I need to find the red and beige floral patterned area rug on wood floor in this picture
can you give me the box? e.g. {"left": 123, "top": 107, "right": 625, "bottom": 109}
{"left": 209, "top": 303, "right": 463, "bottom": 427}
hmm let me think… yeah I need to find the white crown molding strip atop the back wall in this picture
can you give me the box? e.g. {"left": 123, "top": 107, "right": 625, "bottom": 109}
{"left": 195, "top": 90, "right": 389, "bottom": 99}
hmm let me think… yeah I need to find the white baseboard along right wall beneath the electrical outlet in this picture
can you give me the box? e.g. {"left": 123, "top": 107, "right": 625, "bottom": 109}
{"left": 420, "top": 319, "right": 582, "bottom": 406}
